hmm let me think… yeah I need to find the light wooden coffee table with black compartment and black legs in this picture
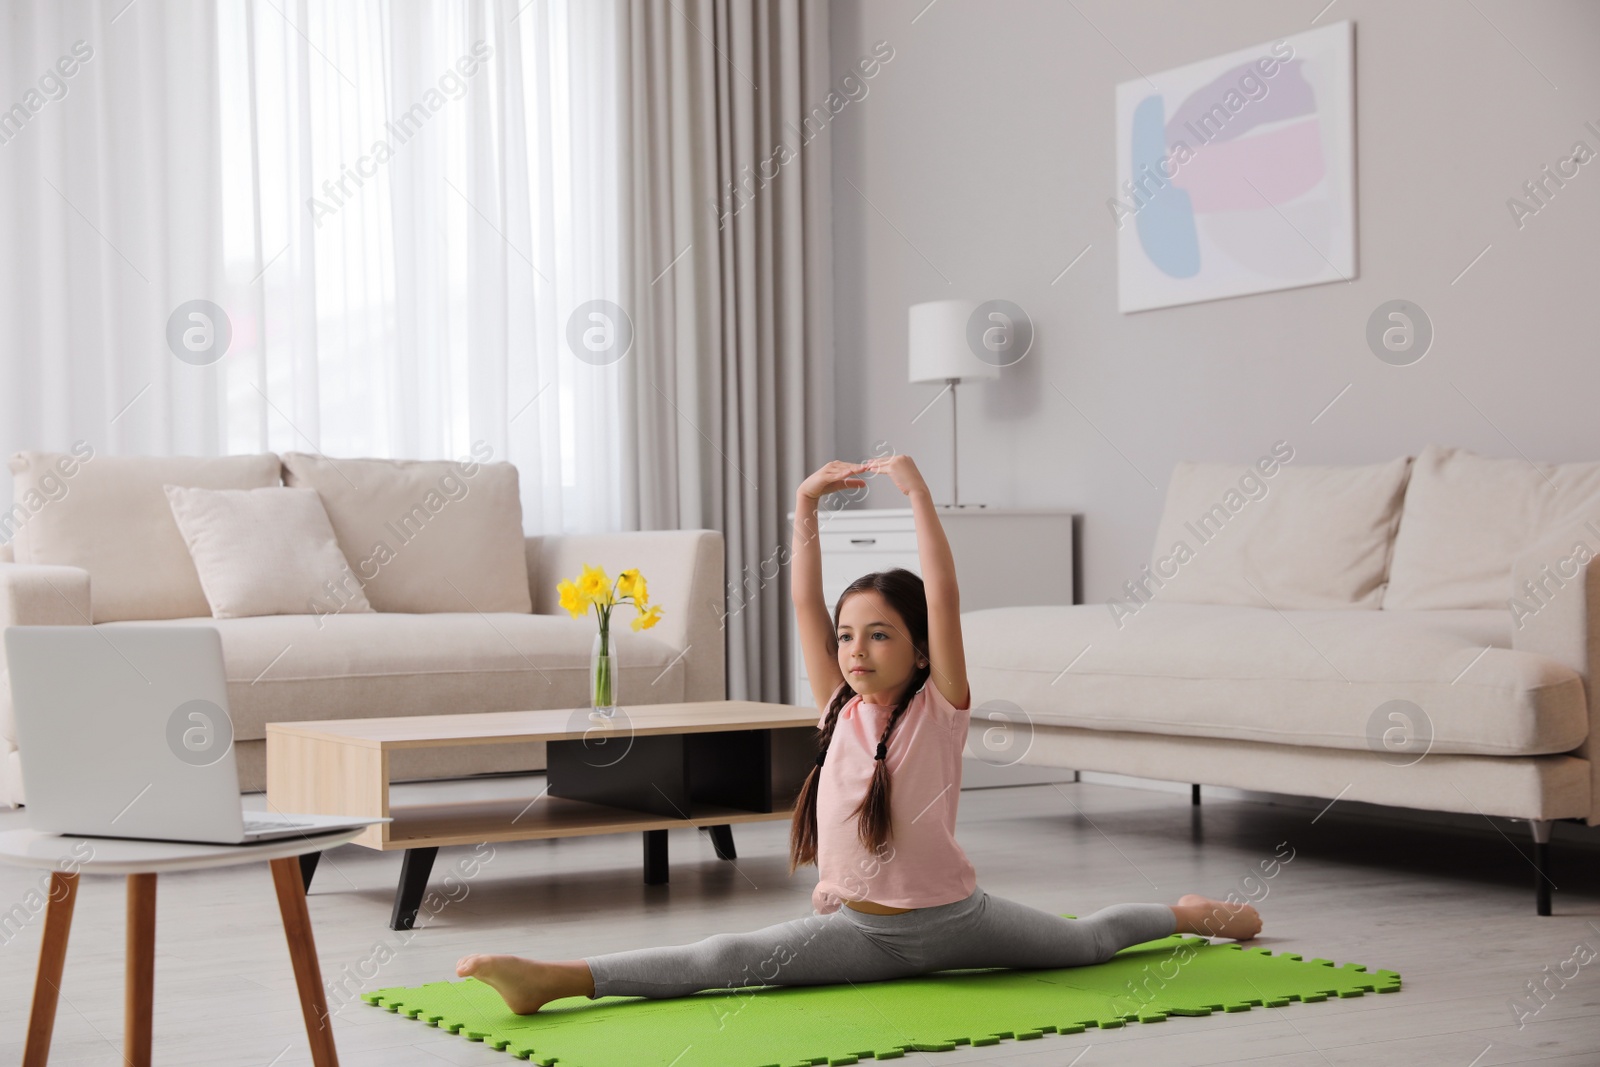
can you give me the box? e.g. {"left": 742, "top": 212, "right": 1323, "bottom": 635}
{"left": 267, "top": 701, "right": 818, "bottom": 929}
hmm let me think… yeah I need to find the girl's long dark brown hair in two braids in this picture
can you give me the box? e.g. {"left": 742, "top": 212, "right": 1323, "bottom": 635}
{"left": 789, "top": 566, "right": 933, "bottom": 873}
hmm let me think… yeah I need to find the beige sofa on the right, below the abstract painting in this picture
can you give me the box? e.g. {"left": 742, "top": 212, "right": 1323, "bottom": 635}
{"left": 963, "top": 443, "right": 1600, "bottom": 913}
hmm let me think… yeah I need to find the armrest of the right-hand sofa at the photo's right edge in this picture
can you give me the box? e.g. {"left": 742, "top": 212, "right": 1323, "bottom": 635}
{"left": 1507, "top": 533, "right": 1600, "bottom": 825}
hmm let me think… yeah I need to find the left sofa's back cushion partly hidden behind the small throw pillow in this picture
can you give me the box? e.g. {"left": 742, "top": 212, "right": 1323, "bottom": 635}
{"left": 11, "top": 451, "right": 280, "bottom": 622}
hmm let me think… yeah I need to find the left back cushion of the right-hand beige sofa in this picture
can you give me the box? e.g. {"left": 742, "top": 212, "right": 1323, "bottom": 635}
{"left": 1128, "top": 450, "right": 1410, "bottom": 611}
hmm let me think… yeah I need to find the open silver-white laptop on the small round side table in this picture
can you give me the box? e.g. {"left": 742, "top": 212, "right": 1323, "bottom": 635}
{"left": 5, "top": 625, "right": 387, "bottom": 845}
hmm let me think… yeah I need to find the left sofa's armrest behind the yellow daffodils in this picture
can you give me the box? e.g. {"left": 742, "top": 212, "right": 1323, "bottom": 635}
{"left": 528, "top": 530, "right": 728, "bottom": 701}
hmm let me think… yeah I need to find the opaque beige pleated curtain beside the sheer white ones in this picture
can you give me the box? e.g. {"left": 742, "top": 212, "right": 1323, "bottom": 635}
{"left": 621, "top": 0, "right": 834, "bottom": 701}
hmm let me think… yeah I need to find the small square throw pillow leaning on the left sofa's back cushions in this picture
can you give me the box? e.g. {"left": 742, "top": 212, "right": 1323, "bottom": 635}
{"left": 166, "top": 485, "right": 373, "bottom": 619}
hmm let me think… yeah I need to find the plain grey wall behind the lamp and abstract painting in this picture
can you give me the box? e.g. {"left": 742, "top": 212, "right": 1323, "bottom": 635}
{"left": 830, "top": 0, "right": 1600, "bottom": 603}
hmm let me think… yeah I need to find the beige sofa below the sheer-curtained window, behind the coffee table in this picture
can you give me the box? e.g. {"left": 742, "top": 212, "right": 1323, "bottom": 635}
{"left": 0, "top": 453, "right": 725, "bottom": 805}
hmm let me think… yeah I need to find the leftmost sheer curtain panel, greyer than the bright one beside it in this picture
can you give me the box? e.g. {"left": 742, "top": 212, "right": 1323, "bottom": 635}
{"left": 0, "top": 0, "right": 224, "bottom": 463}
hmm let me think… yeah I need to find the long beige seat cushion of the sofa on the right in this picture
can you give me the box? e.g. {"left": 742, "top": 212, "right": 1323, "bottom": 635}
{"left": 962, "top": 603, "right": 1589, "bottom": 757}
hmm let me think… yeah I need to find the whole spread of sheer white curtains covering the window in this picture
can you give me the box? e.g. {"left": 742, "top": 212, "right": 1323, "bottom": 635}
{"left": 0, "top": 0, "right": 627, "bottom": 533}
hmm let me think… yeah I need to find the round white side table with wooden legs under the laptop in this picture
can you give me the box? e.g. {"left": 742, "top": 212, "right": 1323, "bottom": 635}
{"left": 0, "top": 827, "right": 362, "bottom": 1067}
